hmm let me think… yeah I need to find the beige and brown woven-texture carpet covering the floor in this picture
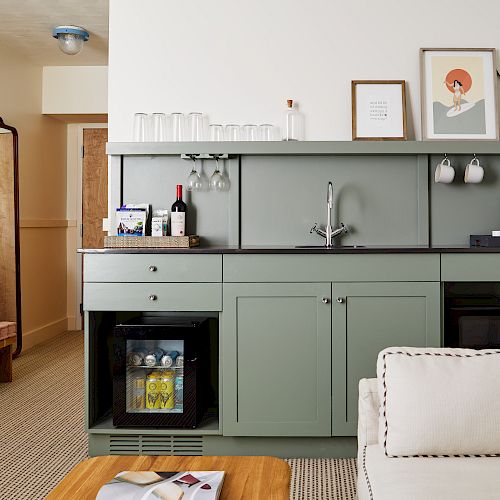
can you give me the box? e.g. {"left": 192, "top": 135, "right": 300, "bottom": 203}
{"left": 0, "top": 332, "right": 356, "bottom": 500}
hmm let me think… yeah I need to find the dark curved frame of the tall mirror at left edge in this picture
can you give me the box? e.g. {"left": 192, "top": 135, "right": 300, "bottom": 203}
{"left": 0, "top": 116, "right": 23, "bottom": 358}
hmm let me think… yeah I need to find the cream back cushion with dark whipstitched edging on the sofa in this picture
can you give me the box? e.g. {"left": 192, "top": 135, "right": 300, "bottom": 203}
{"left": 377, "top": 347, "right": 500, "bottom": 457}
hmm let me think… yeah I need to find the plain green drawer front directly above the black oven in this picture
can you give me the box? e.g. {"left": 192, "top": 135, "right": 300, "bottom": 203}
{"left": 441, "top": 253, "right": 500, "bottom": 281}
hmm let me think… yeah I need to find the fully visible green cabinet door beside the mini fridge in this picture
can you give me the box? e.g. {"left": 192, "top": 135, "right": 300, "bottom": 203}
{"left": 222, "top": 283, "right": 331, "bottom": 436}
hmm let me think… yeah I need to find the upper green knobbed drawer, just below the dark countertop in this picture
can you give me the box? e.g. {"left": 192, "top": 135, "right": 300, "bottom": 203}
{"left": 83, "top": 253, "right": 222, "bottom": 283}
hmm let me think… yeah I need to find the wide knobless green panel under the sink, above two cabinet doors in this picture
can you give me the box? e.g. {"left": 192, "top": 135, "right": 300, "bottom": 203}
{"left": 224, "top": 254, "right": 440, "bottom": 282}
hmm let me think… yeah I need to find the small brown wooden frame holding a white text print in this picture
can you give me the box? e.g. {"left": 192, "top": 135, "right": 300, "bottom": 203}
{"left": 351, "top": 80, "right": 408, "bottom": 141}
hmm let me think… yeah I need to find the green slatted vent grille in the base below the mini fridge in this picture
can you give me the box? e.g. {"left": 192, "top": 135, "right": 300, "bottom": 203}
{"left": 109, "top": 434, "right": 203, "bottom": 456}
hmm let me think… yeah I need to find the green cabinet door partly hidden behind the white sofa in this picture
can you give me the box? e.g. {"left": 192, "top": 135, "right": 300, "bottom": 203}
{"left": 332, "top": 282, "right": 441, "bottom": 436}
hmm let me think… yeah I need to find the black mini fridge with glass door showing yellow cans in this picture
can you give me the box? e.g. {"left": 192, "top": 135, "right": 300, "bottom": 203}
{"left": 113, "top": 316, "right": 211, "bottom": 428}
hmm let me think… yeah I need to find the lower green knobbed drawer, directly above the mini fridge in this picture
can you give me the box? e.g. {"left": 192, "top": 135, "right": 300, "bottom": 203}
{"left": 83, "top": 283, "right": 222, "bottom": 311}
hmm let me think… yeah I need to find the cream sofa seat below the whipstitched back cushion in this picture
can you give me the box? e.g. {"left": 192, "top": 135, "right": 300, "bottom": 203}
{"left": 358, "top": 444, "right": 500, "bottom": 500}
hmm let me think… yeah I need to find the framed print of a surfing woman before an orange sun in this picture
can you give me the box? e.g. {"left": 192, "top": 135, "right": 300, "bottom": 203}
{"left": 420, "top": 49, "right": 498, "bottom": 140}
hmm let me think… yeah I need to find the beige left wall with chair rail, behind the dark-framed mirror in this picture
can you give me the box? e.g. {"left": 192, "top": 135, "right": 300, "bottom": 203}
{"left": 0, "top": 46, "right": 68, "bottom": 348}
